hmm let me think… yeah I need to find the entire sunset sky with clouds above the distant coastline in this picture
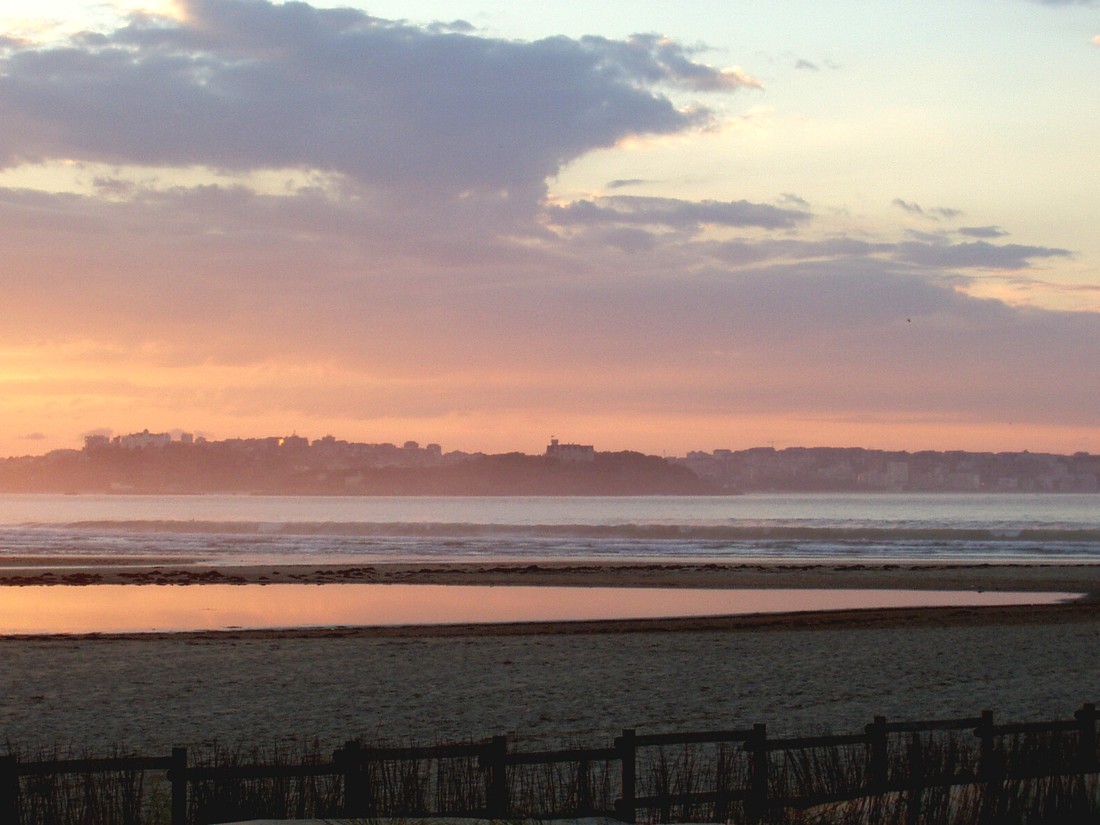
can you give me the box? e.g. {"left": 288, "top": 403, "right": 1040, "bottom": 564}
{"left": 0, "top": 0, "right": 1100, "bottom": 455}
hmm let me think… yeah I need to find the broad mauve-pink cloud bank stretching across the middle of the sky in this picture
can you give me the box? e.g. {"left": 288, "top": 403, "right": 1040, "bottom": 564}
{"left": 0, "top": 174, "right": 1100, "bottom": 437}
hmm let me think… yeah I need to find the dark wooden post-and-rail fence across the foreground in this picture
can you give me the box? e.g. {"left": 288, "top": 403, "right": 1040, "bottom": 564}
{"left": 0, "top": 704, "right": 1100, "bottom": 825}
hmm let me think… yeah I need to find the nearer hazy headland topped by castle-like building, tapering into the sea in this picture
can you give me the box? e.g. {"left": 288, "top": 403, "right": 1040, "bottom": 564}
{"left": 0, "top": 438, "right": 724, "bottom": 496}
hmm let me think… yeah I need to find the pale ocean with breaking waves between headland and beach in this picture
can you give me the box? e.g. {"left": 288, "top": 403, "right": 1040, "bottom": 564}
{"left": 0, "top": 493, "right": 1100, "bottom": 567}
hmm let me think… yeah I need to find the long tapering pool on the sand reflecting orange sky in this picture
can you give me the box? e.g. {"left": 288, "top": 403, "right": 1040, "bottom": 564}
{"left": 0, "top": 584, "right": 1074, "bottom": 635}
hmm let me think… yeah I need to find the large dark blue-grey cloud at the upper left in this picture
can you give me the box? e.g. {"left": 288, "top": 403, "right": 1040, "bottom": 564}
{"left": 0, "top": 0, "right": 756, "bottom": 208}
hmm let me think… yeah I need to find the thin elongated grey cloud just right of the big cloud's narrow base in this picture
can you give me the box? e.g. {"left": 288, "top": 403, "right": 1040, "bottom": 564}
{"left": 549, "top": 195, "right": 811, "bottom": 231}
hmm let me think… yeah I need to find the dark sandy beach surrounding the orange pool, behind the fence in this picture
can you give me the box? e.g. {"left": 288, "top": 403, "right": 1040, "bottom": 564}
{"left": 0, "top": 564, "right": 1100, "bottom": 750}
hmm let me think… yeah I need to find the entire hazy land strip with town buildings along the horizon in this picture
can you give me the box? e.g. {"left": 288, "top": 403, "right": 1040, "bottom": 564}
{"left": 0, "top": 430, "right": 1100, "bottom": 495}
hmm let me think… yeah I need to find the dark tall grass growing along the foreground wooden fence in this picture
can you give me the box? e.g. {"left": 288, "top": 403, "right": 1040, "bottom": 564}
{"left": 10, "top": 733, "right": 1100, "bottom": 825}
